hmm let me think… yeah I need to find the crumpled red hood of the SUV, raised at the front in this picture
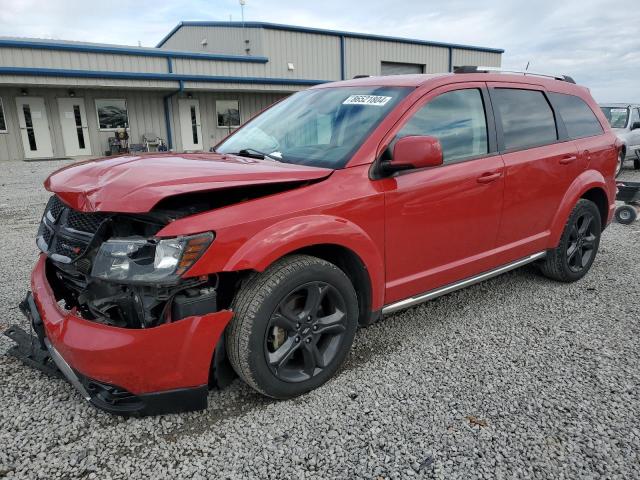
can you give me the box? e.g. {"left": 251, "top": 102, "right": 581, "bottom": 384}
{"left": 44, "top": 153, "right": 333, "bottom": 213}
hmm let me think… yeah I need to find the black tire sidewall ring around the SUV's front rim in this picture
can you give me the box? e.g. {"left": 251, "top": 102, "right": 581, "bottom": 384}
{"left": 248, "top": 263, "right": 358, "bottom": 398}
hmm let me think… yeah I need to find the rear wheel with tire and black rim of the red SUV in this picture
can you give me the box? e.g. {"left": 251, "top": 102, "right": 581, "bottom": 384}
{"left": 540, "top": 199, "right": 602, "bottom": 282}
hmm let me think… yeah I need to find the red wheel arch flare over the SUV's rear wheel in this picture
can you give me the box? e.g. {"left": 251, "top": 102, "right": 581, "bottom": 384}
{"left": 548, "top": 170, "right": 615, "bottom": 248}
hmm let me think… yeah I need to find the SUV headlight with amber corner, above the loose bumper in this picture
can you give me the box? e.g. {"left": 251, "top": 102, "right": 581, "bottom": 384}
{"left": 91, "top": 232, "right": 213, "bottom": 283}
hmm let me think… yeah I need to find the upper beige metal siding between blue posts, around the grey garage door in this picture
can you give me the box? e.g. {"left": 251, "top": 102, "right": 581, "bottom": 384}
{"left": 345, "top": 38, "right": 449, "bottom": 78}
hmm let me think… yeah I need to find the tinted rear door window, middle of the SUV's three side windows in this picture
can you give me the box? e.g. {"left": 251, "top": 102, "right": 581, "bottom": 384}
{"left": 492, "top": 88, "right": 558, "bottom": 150}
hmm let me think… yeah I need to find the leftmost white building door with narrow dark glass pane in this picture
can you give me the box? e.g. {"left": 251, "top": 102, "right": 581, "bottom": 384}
{"left": 16, "top": 97, "right": 53, "bottom": 158}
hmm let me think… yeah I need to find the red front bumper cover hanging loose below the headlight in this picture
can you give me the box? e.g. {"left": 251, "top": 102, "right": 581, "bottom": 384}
{"left": 31, "top": 255, "right": 232, "bottom": 394}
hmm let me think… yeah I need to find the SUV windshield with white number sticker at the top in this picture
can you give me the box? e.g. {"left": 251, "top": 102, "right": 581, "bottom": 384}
{"left": 216, "top": 86, "right": 410, "bottom": 169}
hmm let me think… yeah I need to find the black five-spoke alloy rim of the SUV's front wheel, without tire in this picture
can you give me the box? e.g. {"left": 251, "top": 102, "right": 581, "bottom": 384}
{"left": 265, "top": 281, "right": 347, "bottom": 382}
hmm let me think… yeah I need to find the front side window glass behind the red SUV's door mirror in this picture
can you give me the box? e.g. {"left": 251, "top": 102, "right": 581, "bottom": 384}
{"left": 396, "top": 89, "right": 489, "bottom": 164}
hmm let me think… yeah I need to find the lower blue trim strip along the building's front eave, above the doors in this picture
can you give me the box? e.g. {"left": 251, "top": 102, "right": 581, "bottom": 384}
{"left": 0, "top": 67, "right": 334, "bottom": 86}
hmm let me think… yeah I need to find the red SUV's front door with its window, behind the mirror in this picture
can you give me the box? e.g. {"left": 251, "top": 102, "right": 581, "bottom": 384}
{"left": 384, "top": 83, "right": 504, "bottom": 304}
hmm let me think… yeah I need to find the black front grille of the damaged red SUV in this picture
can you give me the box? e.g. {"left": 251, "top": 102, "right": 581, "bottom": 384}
{"left": 38, "top": 195, "right": 108, "bottom": 263}
